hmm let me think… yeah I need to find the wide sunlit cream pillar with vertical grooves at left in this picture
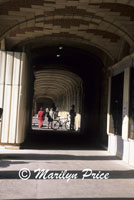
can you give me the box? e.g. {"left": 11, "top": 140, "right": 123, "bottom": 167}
{"left": 0, "top": 51, "right": 28, "bottom": 144}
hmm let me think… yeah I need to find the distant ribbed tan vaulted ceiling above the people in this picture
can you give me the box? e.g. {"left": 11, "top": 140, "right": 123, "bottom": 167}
{"left": 34, "top": 69, "right": 82, "bottom": 102}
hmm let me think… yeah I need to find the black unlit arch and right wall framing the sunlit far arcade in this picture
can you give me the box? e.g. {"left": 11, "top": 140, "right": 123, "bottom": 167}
{"left": 25, "top": 45, "right": 103, "bottom": 141}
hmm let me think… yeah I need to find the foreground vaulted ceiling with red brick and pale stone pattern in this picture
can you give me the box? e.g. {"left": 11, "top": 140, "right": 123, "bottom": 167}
{"left": 0, "top": 0, "right": 134, "bottom": 63}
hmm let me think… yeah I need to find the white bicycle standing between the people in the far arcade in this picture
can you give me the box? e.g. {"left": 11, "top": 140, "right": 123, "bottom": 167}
{"left": 53, "top": 115, "right": 70, "bottom": 130}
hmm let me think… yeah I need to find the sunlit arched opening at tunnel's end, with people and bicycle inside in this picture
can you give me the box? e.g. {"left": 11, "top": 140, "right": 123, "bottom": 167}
{"left": 32, "top": 69, "right": 83, "bottom": 132}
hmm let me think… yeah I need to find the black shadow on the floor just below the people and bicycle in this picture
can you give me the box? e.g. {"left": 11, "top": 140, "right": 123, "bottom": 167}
{"left": 21, "top": 130, "right": 107, "bottom": 150}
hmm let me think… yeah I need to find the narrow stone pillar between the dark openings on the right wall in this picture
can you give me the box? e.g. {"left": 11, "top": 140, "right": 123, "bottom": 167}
{"left": 122, "top": 68, "right": 130, "bottom": 140}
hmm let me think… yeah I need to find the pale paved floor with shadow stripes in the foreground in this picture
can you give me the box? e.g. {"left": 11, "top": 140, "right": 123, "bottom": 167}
{"left": 0, "top": 139, "right": 134, "bottom": 200}
